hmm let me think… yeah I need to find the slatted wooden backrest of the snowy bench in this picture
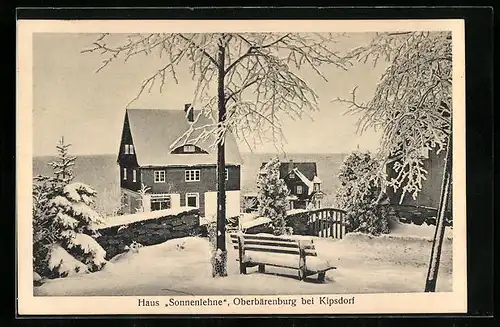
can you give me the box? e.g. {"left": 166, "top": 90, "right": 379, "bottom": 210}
{"left": 230, "top": 234, "right": 317, "bottom": 257}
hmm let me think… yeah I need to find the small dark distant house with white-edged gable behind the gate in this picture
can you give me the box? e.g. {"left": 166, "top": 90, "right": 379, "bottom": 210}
{"left": 261, "top": 160, "right": 324, "bottom": 209}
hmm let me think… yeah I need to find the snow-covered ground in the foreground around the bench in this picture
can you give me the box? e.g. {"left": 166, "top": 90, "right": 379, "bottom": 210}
{"left": 35, "top": 224, "right": 452, "bottom": 296}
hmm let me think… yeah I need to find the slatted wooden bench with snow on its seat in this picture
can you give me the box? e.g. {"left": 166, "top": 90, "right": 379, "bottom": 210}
{"left": 230, "top": 233, "right": 336, "bottom": 281}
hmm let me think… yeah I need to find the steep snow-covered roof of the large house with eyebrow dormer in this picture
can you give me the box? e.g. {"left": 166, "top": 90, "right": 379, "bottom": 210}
{"left": 126, "top": 109, "right": 243, "bottom": 167}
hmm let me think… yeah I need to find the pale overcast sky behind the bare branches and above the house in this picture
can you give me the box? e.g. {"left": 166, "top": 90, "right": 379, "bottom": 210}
{"left": 33, "top": 33, "right": 384, "bottom": 155}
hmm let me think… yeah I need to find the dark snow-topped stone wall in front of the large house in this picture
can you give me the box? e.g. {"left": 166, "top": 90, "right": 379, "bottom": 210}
{"left": 96, "top": 209, "right": 200, "bottom": 260}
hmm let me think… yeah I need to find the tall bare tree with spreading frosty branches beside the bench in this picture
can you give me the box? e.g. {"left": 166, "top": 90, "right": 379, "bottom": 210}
{"left": 84, "top": 33, "right": 346, "bottom": 276}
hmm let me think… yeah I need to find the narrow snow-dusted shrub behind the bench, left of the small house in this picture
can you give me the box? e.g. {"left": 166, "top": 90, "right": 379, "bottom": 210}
{"left": 257, "top": 158, "right": 290, "bottom": 235}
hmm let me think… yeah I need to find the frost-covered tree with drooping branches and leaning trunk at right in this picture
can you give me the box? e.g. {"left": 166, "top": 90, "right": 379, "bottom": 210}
{"left": 336, "top": 32, "right": 452, "bottom": 291}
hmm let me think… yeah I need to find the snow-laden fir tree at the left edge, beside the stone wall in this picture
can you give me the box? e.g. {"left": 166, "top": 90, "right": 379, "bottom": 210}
{"left": 33, "top": 138, "right": 106, "bottom": 277}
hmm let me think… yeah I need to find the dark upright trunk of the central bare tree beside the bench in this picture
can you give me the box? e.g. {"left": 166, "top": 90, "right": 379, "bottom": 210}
{"left": 212, "top": 39, "right": 227, "bottom": 277}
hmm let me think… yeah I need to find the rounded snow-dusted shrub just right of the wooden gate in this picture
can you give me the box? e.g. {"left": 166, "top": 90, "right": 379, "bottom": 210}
{"left": 336, "top": 151, "right": 391, "bottom": 235}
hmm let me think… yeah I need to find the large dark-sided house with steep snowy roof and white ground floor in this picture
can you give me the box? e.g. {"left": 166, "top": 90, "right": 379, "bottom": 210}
{"left": 118, "top": 104, "right": 242, "bottom": 219}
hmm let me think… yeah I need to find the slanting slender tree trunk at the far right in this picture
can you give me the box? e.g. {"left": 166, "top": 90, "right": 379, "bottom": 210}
{"left": 425, "top": 137, "right": 452, "bottom": 292}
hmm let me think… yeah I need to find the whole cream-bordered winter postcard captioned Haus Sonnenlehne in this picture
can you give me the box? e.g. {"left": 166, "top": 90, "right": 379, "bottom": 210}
{"left": 16, "top": 20, "right": 467, "bottom": 315}
